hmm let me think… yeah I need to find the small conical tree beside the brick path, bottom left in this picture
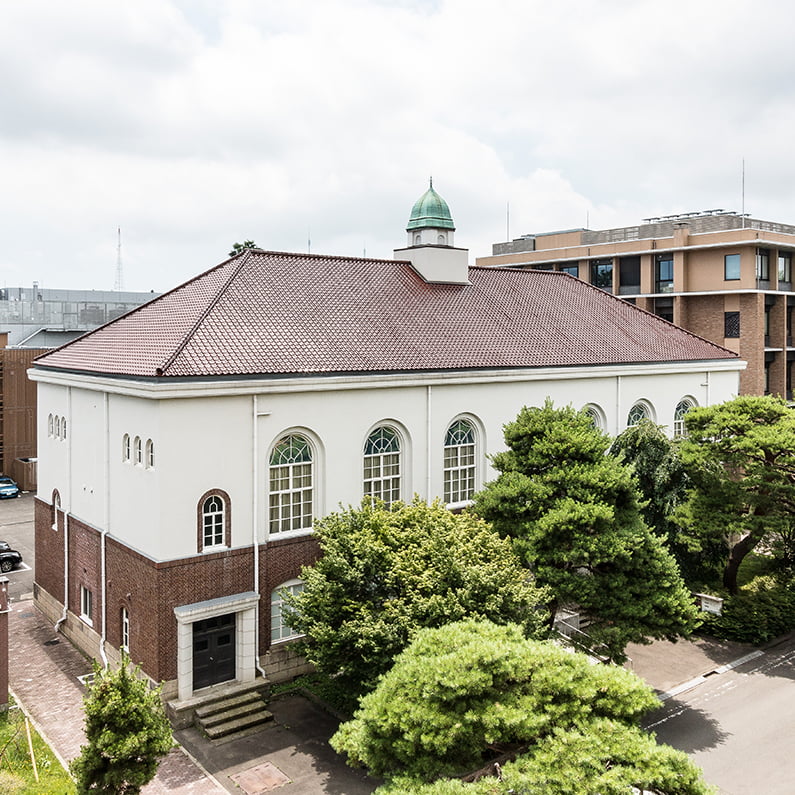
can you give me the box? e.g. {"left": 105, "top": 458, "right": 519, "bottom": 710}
{"left": 69, "top": 654, "right": 173, "bottom": 795}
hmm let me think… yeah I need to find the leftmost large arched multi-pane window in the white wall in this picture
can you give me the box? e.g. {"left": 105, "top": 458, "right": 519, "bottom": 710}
{"left": 268, "top": 434, "right": 312, "bottom": 533}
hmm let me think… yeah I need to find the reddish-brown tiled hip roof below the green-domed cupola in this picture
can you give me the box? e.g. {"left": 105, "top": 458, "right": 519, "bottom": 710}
{"left": 36, "top": 251, "right": 735, "bottom": 377}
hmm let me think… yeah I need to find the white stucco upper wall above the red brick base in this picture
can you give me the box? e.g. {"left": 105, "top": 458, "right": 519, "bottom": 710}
{"left": 33, "top": 362, "right": 742, "bottom": 560}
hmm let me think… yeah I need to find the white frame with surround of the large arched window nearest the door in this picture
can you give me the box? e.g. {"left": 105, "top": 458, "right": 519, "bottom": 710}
{"left": 267, "top": 430, "right": 317, "bottom": 538}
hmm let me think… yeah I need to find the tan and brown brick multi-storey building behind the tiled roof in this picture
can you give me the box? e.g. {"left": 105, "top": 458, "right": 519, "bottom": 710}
{"left": 477, "top": 210, "right": 795, "bottom": 399}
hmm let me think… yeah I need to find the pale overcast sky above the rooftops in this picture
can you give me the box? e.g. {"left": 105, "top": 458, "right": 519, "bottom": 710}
{"left": 0, "top": 0, "right": 795, "bottom": 291}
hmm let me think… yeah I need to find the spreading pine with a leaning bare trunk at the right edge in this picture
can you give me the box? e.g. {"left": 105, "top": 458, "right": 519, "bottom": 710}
{"left": 681, "top": 396, "right": 795, "bottom": 594}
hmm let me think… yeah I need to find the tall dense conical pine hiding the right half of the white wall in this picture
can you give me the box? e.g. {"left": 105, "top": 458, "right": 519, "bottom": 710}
{"left": 475, "top": 400, "right": 696, "bottom": 661}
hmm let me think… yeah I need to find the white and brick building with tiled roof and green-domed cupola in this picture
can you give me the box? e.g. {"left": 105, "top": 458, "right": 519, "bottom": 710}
{"left": 31, "top": 182, "right": 744, "bottom": 702}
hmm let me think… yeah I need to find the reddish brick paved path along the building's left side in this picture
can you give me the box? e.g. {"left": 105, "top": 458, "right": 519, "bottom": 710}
{"left": 9, "top": 601, "right": 227, "bottom": 795}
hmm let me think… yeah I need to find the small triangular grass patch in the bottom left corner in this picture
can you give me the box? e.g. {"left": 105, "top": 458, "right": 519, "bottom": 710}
{"left": 0, "top": 699, "right": 75, "bottom": 795}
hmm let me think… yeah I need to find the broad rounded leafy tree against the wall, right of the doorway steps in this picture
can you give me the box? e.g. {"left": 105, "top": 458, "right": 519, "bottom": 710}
{"left": 287, "top": 498, "right": 546, "bottom": 698}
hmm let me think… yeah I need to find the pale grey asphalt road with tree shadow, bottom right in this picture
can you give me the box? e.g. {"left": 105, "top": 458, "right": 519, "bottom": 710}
{"left": 644, "top": 636, "right": 795, "bottom": 795}
